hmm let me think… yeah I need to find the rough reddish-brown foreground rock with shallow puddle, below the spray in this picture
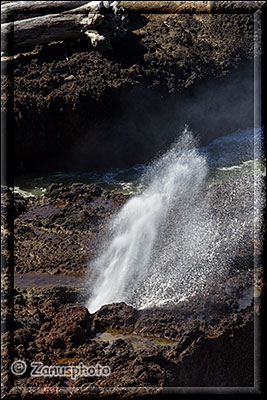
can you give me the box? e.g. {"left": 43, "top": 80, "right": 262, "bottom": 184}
{"left": 7, "top": 284, "right": 257, "bottom": 389}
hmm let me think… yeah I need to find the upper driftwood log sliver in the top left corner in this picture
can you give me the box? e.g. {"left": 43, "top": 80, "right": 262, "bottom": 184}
{"left": 1, "top": 1, "right": 88, "bottom": 22}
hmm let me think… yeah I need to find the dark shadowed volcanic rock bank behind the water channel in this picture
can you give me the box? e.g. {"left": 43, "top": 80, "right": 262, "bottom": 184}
{"left": 2, "top": 8, "right": 259, "bottom": 174}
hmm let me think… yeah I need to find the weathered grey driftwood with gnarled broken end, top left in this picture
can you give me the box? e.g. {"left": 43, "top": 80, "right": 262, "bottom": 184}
{"left": 1, "top": 1, "right": 127, "bottom": 53}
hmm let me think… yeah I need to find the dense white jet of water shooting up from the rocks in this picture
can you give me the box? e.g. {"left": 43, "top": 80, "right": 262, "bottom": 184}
{"left": 88, "top": 128, "right": 208, "bottom": 312}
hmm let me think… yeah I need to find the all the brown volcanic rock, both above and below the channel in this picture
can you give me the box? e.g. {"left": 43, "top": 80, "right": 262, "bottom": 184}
{"left": 1, "top": 2, "right": 266, "bottom": 399}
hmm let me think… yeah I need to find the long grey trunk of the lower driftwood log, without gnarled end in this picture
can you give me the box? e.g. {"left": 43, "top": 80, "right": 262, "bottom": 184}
{"left": 1, "top": 13, "right": 103, "bottom": 50}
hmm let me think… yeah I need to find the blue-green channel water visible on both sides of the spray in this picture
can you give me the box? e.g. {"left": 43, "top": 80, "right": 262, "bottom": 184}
{"left": 14, "top": 128, "right": 266, "bottom": 197}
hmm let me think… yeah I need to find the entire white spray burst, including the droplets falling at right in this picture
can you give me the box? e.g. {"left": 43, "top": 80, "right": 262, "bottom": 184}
{"left": 87, "top": 128, "right": 262, "bottom": 312}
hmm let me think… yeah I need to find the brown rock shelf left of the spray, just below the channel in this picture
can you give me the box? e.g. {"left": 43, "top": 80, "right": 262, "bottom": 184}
{"left": 14, "top": 183, "right": 128, "bottom": 275}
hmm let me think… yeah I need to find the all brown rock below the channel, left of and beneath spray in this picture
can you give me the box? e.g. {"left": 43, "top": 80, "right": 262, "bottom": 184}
{"left": 2, "top": 184, "right": 263, "bottom": 398}
